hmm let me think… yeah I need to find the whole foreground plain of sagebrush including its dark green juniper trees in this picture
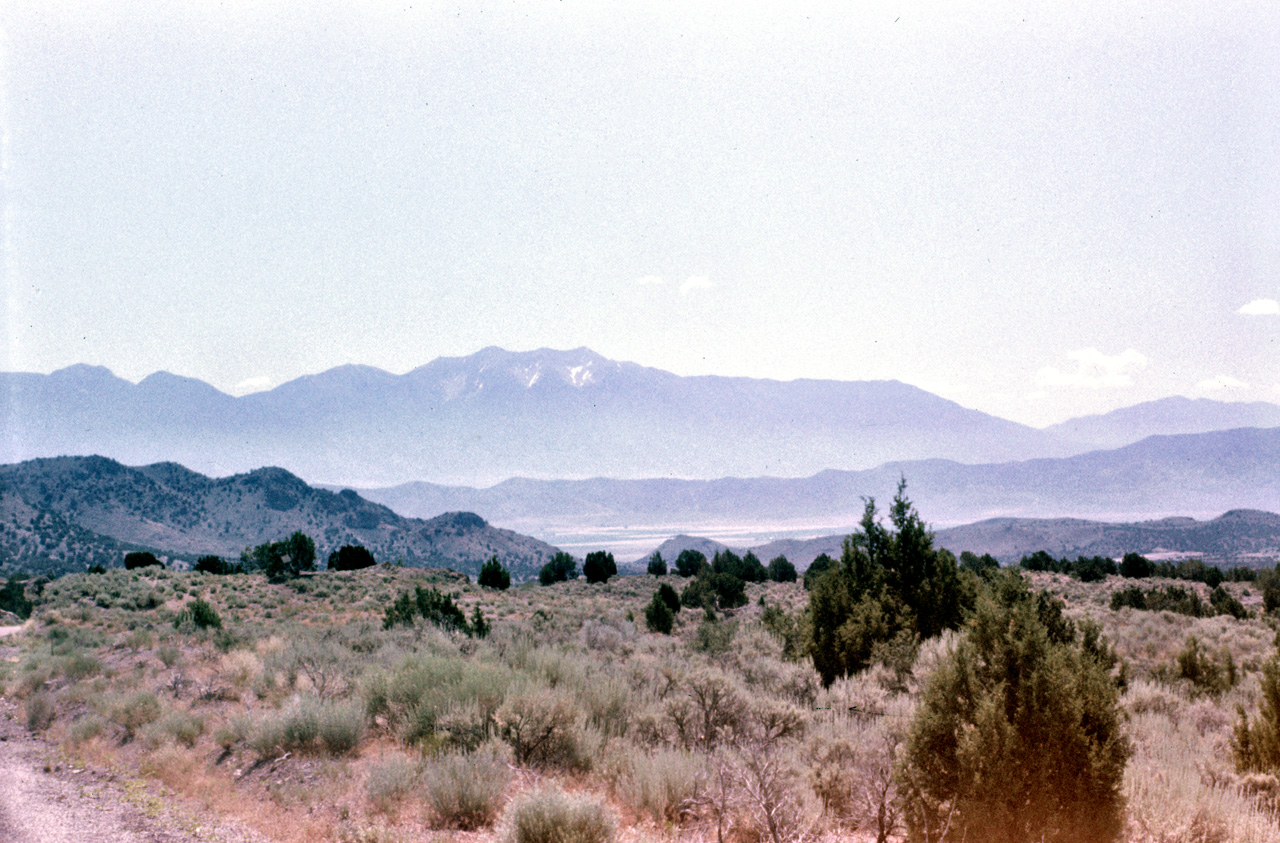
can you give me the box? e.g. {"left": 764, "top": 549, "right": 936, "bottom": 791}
{"left": 0, "top": 489, "right": 1280, "bottom": 843}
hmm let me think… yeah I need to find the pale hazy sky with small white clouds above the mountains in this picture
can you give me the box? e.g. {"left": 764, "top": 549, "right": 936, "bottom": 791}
{"left": 0, "top": 0, "right": 1280, "bottom": 423}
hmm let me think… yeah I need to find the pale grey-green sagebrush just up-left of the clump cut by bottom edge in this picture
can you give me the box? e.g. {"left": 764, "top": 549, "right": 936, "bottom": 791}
{"left": 422, "top": 743, "right": 511, "bottom": 831}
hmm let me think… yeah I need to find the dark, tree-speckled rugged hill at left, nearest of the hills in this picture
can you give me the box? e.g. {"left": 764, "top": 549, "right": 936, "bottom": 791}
{"left": 0, "top": 457, "right": 556, "bottom": 579}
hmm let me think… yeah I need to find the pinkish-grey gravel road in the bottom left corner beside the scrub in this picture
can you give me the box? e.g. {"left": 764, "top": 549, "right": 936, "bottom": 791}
{"left": 0, "top": 698, "right": 257, "bottom": 843}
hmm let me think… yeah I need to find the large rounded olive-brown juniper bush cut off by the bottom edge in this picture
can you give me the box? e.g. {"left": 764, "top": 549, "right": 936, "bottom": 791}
{"left": 896, "top": 572, "right": 1129, "bottom": 843}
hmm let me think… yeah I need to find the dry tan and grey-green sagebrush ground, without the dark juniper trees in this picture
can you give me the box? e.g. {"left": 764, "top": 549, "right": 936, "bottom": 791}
{"left": 0, "top": 565, "right": 1280, "bottom": 843}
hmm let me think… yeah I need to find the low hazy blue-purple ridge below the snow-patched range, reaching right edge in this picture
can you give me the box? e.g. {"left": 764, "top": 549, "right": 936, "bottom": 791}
{"left": 350, "top": 429, "right": 1280, "bottom": 535}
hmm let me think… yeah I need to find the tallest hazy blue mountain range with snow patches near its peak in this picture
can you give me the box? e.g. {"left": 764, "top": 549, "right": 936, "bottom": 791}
{"left": 0, "top": 348, "right": 1116, "bottom": 485}
